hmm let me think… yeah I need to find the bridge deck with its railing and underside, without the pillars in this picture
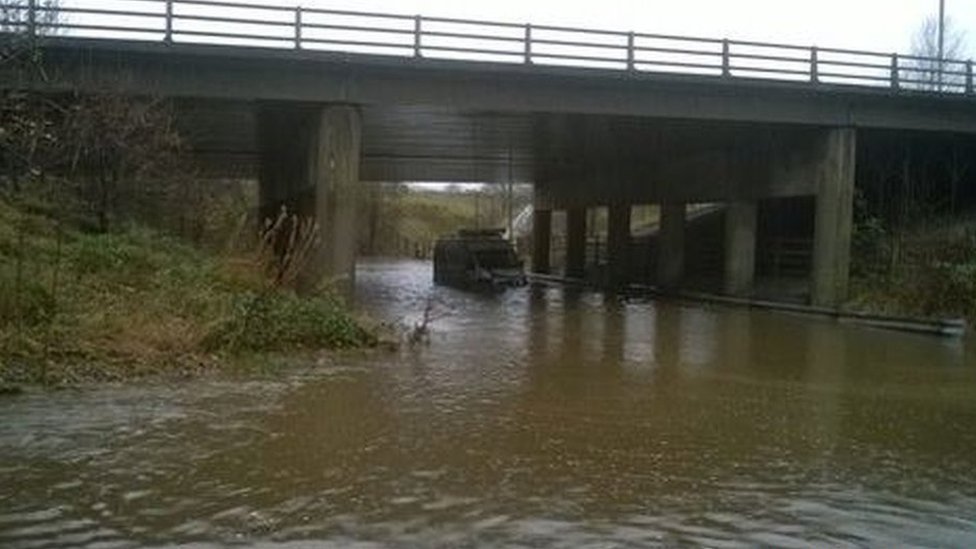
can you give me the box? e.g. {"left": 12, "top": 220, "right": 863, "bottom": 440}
{"left": 0, "top": 0, "right": 976, "bottom": 181}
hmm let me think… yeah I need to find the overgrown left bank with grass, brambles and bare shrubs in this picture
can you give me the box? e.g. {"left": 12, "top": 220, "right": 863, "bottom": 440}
{"left": 0, "top": 36, "right": 376, "bottom": 388}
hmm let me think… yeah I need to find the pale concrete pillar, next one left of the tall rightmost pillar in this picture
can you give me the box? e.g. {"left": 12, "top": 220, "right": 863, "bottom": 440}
{"left": 725, "top": 201, "right": 757, "bottom": 296}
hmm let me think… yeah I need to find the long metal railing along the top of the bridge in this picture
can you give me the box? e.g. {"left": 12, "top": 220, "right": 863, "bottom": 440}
{"left": 0, "top": 0, "right": 976, "bottom": 96}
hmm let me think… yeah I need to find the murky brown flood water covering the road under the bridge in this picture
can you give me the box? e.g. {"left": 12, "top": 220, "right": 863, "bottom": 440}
{"left": 0, "top": 262, "right": 976, "bottom": 547}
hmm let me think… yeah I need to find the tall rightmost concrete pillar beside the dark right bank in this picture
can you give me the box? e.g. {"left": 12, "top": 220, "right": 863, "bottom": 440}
{"left": 810, "top": 128, "right": 857, "bottom": 307}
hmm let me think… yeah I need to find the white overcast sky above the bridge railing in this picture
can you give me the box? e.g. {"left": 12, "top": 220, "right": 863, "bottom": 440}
{"left": 286, "top": 0, "right": 976, "bottom": 58}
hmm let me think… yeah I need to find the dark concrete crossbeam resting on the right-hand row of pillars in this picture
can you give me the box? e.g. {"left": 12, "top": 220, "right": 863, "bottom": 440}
{"left": 536, "top": 128, "right": 822, "bottom": 209}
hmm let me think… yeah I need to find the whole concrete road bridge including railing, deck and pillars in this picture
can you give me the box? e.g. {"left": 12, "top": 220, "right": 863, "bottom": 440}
{"left": 0, "top": 0, "right": 976, "bottom": 305}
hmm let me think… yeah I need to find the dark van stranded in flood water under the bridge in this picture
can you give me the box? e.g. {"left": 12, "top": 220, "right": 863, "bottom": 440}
{"left": 434, "top": 229, "right": 526, "bottom": 288}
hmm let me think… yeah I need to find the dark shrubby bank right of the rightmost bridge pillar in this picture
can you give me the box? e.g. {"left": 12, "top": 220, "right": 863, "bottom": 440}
{"left": 848, "top": 130, "right": 976, "bottom": 325}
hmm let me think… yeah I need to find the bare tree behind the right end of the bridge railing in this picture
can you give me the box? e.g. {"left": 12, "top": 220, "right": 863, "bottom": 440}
{"left": 901, "top": 16, "right": 966, "bottom": 90}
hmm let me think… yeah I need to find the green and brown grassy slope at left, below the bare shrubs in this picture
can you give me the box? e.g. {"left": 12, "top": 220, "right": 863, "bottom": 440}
{"left": 0, "top": 197, "right": 376, "bottom": 384}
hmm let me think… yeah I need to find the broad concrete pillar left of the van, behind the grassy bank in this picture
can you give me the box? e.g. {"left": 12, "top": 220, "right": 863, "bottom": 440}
{"left": 258, "top": 103, "right": 362, "bottom": 292}
